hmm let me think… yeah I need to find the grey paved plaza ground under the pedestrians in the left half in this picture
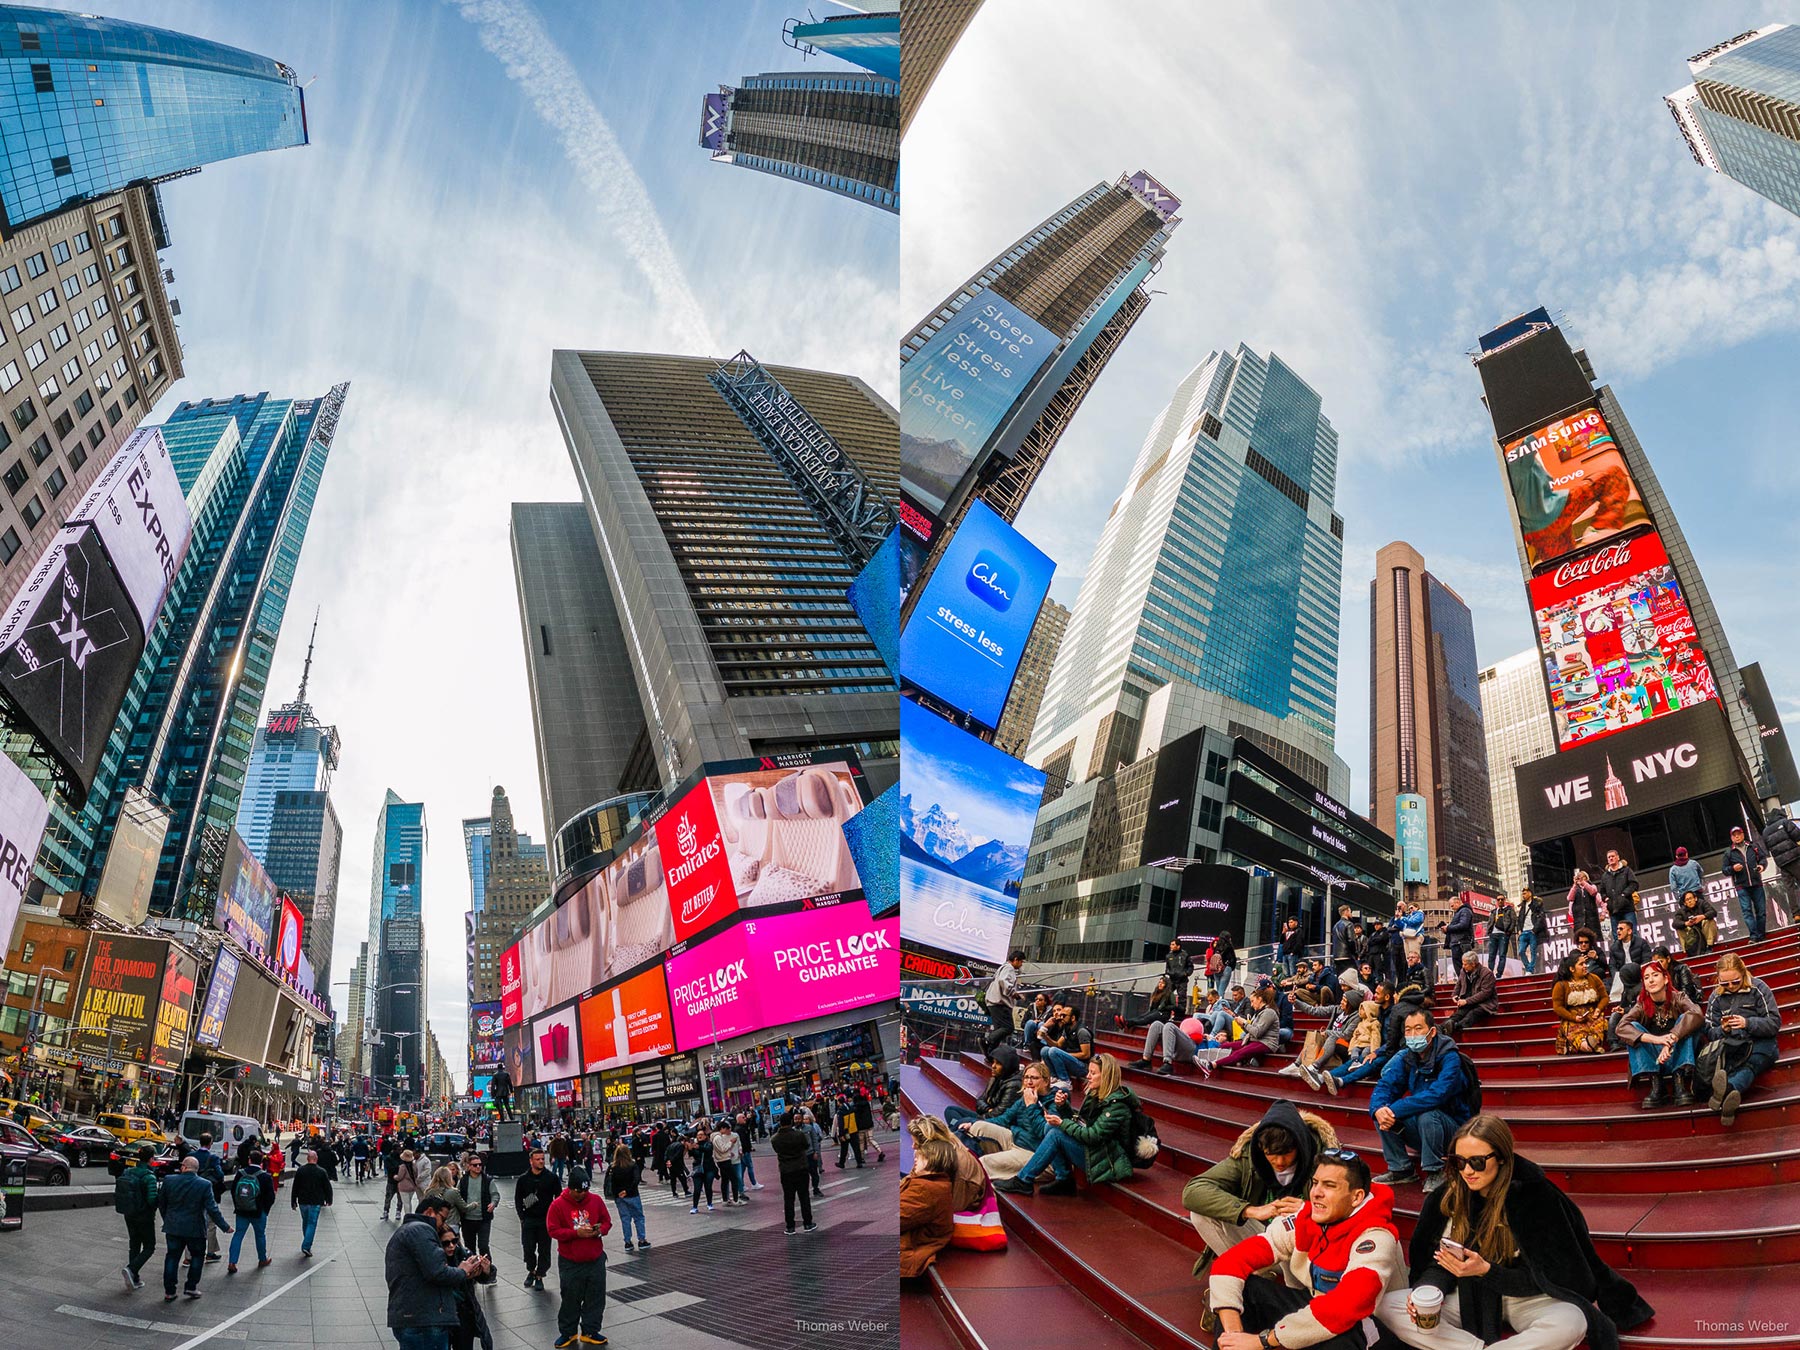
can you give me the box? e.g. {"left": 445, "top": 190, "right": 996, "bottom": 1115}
{"left": 0, "top": 1141, "right": 900, "bottom": 1350}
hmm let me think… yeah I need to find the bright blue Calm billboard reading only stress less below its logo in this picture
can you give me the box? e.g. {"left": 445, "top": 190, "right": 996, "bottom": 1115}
{"left": 900, "top": 502, "right": 1057, "bottom": 727}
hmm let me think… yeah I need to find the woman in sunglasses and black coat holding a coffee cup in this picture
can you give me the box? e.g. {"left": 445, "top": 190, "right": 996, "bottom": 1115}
{"left": 1377, "top": 1112, "right": 1652, "bottom": 1350}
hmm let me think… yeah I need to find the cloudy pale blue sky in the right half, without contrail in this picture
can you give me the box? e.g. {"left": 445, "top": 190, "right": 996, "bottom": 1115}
{"left": 900, "top": 0, "right": 1800, "bottom": 810}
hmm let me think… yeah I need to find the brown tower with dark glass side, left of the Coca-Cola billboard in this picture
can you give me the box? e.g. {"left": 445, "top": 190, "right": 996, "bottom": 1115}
{"left": 1368, "top": 542, "right": 1499, "bottom": 923}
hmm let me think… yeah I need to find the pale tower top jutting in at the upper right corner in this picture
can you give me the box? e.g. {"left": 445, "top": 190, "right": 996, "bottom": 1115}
{"left": 1663, "top": 23, "right": 1800, "bottom": 216}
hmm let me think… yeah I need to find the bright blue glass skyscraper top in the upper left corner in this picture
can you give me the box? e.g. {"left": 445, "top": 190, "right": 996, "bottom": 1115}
{"left": 0, "top": 5, "right": 306, "bottom": 234}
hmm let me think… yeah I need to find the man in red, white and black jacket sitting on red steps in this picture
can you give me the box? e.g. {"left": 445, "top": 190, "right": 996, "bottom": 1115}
{"left": 1201, "top": 1148, "right": 1406, "bottom": 1350}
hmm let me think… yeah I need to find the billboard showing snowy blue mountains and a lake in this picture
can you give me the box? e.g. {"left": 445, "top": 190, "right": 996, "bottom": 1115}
{"left": 900, "top": 698, "right": 1044, "bottom": 965}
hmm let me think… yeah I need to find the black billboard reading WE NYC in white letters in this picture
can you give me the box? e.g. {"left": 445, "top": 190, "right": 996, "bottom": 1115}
{"left": 1512, "top": 704, "right": 1742, "bottom": 844}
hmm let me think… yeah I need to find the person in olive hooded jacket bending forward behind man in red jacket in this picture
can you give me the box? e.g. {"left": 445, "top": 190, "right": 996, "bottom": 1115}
{"left": 1181, "top": 1102, "right": 1337, "bottom": 1280}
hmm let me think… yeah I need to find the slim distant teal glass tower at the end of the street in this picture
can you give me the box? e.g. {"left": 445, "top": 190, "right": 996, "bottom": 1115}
{"left": 364, "top": 788, "right": 430, "bottom": 1091}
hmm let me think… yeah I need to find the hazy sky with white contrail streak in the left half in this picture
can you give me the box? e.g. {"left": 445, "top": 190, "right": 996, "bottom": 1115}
{"left": 87, "top": 0, "right": 898, "bottom": 1066}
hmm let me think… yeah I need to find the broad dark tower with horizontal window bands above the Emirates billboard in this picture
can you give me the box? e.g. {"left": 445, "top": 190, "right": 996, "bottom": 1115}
{"left": 527, "top": 351, "right": 900, "bottom": 792}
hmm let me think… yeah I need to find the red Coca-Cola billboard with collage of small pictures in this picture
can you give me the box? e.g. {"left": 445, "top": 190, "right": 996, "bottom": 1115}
{"left": 1530, "top": 535, "right": 1719, "bottom": 749}
